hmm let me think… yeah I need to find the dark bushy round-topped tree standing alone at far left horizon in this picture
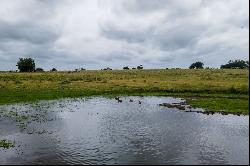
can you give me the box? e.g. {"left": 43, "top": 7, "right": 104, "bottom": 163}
{"left": 17, "top": 58, "right": 36, "bottom": 72}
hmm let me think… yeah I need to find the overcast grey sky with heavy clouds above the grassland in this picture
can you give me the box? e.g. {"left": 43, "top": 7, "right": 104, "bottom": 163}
{"left": 0, "top": 0, "right": 249, "bottom": 70}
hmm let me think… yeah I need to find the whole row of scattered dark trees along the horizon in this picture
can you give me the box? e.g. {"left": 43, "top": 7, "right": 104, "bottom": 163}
{"left": 16, "top": 58, "right": 249, "bottom": 72}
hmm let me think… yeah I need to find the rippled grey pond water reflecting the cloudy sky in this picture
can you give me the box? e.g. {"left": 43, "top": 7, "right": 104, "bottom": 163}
{"left": 0, "top": 97, "right": 249, "bottom": 164}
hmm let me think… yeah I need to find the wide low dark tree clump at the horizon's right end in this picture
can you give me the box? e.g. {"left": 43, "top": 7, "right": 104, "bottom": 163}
{"left": 220, "top": 59, "right": 249, "bottom": 69}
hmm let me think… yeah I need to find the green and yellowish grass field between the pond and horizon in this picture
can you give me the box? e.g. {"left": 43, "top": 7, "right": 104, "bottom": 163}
{"left": 0, "top": 69, "right": 249, "bottom": 114}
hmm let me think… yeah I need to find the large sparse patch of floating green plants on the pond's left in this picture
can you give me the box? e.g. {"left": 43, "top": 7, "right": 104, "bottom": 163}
{"left": 0, "top": 99, "right": 85, "bottom": 135}
